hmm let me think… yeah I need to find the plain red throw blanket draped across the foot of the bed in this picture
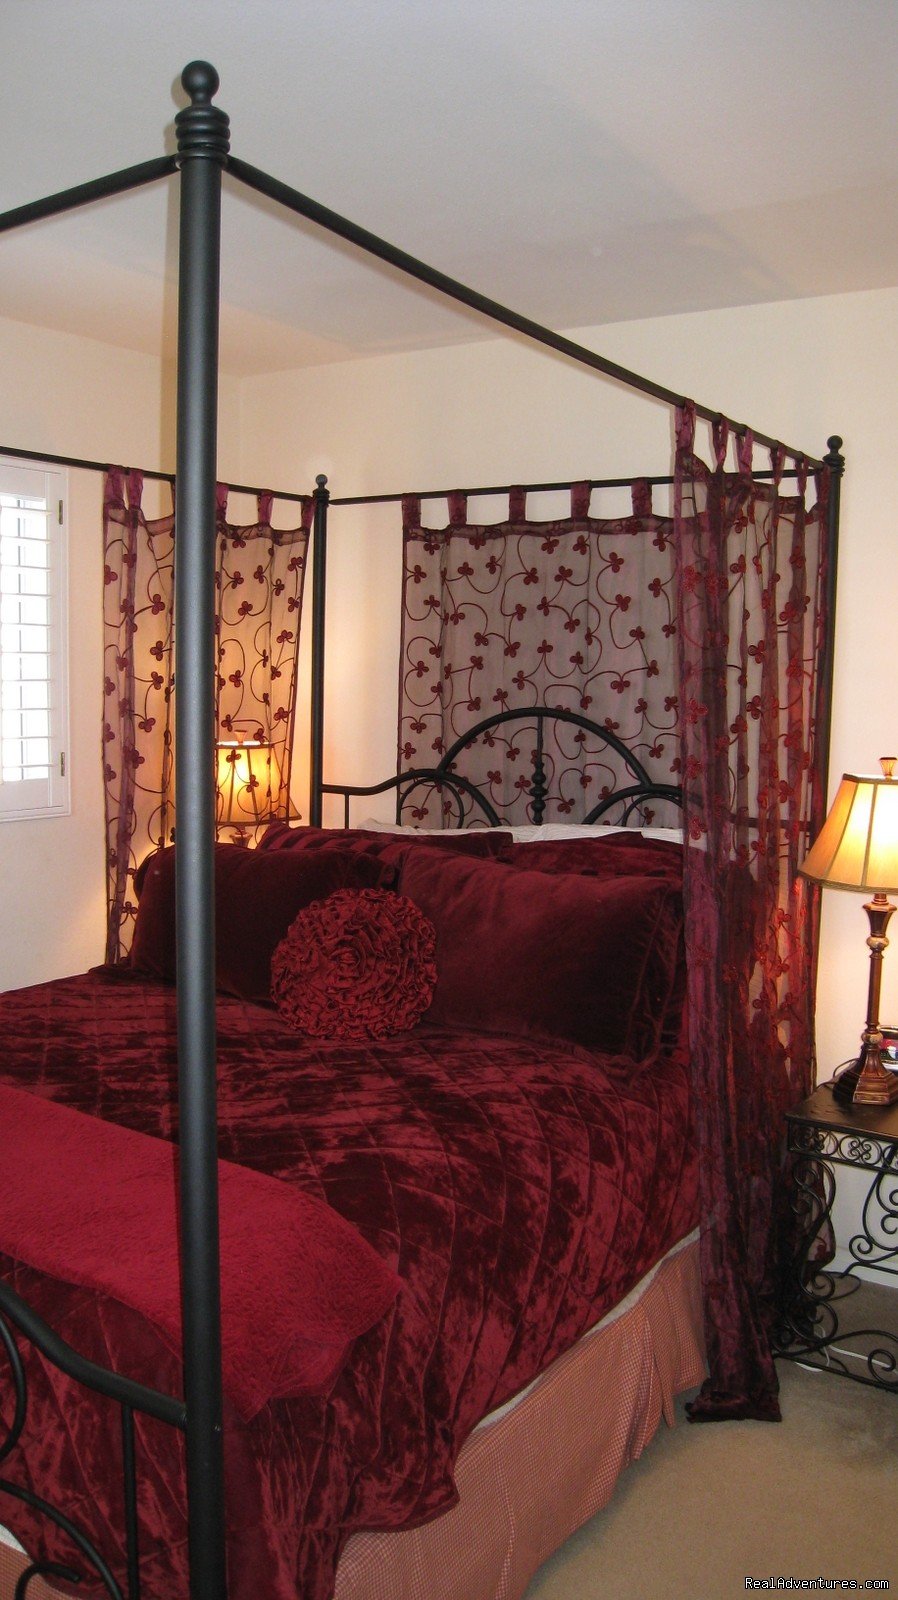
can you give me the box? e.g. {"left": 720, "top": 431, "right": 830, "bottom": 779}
{"left": 0, "top": 1083, "right": 400, "bottom": 1421}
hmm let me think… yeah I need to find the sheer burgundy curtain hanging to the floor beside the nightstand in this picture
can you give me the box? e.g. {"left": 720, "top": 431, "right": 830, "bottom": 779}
{"left": 674, "top": 406, "right": 829, "bottom": 1419}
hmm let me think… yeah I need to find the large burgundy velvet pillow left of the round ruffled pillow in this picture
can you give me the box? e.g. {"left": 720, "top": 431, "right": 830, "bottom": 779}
{"left": 131, "top": 845, "right": 395, "bottom": 1002}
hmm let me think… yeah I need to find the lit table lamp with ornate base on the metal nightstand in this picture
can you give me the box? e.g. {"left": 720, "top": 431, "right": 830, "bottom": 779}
{"left": 799, "top": 755, "right": 898, "bottom": 1106}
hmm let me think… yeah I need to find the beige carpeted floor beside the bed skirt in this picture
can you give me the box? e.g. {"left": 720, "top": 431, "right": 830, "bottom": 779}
{"left": 527, "top": 1362, "right": 898, "bottom": 1600}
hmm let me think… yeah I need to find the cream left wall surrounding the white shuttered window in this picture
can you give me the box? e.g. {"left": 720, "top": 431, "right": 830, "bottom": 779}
{"left": 0, "top": 320, "right": 239, "bottom": 989}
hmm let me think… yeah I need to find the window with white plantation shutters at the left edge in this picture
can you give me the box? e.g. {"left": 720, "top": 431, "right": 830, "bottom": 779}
{"left": 0, "top": 456, "right": 69, "bottom": 821}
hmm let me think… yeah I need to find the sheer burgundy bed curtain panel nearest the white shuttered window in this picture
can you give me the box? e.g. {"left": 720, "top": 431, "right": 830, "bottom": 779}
{"left": 102, "top": 469, "right": 314, "bottom": 962}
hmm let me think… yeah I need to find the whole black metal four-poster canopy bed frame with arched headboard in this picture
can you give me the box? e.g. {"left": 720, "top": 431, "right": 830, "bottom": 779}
{"left": 0, "top": 61, "right": 844, "bottom": 1600}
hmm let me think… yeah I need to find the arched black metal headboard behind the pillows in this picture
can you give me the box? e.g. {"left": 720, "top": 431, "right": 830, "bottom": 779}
{"left": 322, "top": 706, "right": 684, "bottom": 827}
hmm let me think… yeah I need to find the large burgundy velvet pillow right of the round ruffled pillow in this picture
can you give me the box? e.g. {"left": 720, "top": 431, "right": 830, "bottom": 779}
{"left": 399, "top": 850, "right": 682, "bottom": 1061}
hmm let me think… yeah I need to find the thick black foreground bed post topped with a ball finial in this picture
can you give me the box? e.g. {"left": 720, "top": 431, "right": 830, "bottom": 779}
{"left": 174, "top": 61, "right": 229, "bottom": 1600}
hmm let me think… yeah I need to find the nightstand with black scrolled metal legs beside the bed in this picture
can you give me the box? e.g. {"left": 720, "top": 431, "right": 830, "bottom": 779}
{"left": 773, "top": 1083, "right": 898, "bottom": 1394}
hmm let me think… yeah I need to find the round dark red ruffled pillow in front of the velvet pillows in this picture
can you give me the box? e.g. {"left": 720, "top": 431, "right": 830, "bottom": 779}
{"left": 271, "top": 890, "right": 437, "bottom": 1040}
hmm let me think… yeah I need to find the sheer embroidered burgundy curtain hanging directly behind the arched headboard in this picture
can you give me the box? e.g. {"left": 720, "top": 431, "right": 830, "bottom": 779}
{"left": 399, "top": 478, "right": 679, "bottom": 827}
